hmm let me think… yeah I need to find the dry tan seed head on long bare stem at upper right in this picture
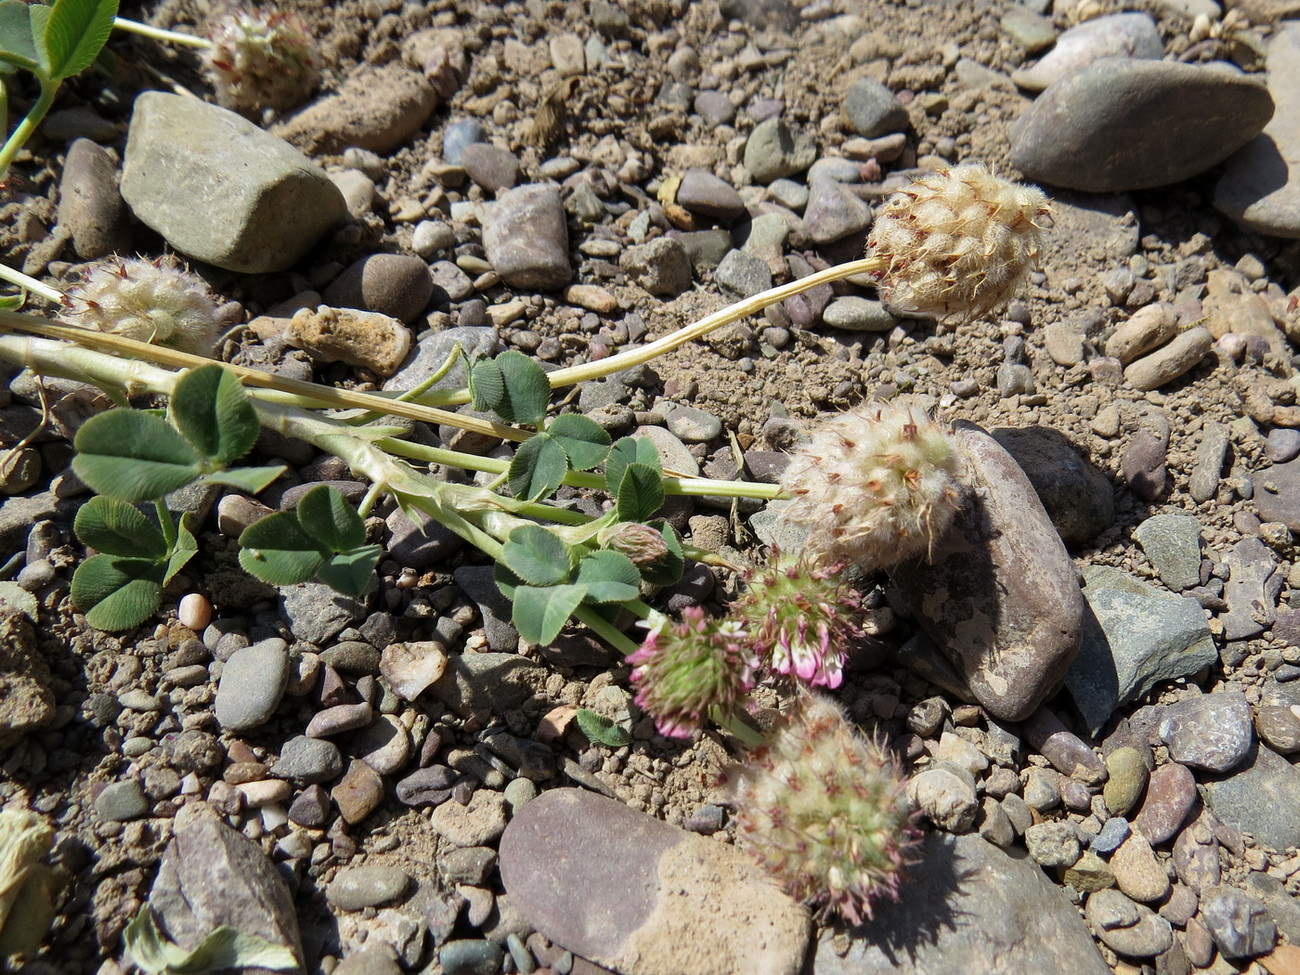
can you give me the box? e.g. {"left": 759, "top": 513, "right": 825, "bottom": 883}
{"left": 867, "top": 163, "right": 1050, "bottom": 321}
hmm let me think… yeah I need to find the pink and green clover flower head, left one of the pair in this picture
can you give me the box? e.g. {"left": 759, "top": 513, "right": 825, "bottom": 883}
{"left": 628, "top": 606, "right": 757, "bottom": 738}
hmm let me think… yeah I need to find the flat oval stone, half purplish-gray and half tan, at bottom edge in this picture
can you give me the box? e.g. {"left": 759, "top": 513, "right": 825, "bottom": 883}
{"left": 501, "top": 789, "right": 809, "bottom": 975}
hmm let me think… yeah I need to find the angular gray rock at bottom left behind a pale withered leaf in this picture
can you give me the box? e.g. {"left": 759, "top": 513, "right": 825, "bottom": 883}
{"left": 150, "top": 802, "right": 303, "bottom": 975}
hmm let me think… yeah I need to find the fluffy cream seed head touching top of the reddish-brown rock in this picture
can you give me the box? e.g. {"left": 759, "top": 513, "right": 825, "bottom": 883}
{"left": 781, "top": 403, "right": 961, "bottom": 569}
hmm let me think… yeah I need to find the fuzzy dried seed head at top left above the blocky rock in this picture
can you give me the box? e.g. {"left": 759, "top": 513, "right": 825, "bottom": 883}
{"left": 207, "top": 9, "right": 320, "bottom": 116}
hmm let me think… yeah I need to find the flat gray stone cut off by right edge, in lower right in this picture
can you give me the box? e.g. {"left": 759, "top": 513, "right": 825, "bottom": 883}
{"left": 1204, "top": 745, "right": 1300, "bottom": 850}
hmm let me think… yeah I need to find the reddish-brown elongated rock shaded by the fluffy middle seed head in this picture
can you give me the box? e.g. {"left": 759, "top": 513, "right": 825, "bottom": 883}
{"left": 893, "top": 423, "right": 1083, "bottom": 722}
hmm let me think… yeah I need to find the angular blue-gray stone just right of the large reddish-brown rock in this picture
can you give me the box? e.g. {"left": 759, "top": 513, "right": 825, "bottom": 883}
{"left": 1066, "top": 567, "right": 1218, "bottom": 735}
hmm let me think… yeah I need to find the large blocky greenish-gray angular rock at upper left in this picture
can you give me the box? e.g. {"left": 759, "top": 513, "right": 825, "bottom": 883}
{"left": 122, "top": 91, "right": 347, "bottom": 274}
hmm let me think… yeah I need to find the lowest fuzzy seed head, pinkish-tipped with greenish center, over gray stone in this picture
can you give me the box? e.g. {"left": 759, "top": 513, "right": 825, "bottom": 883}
{"left": 731, "top": 692, "right": 919, "bottom": 924}
